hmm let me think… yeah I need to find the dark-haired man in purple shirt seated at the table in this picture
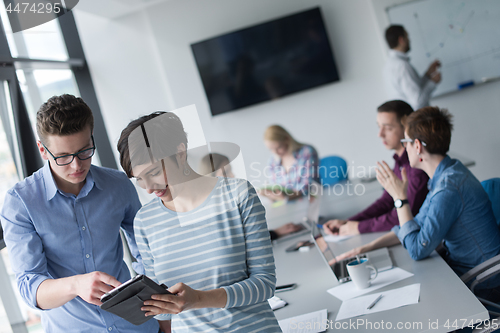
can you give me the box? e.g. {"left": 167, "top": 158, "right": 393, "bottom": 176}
{"left": 323, "top": 100, "right": 429, "bottom": 235}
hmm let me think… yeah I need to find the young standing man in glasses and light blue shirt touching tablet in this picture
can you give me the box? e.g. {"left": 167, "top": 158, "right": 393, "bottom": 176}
{"left": 1, "top": 95, "right": 159, "bottom": 333}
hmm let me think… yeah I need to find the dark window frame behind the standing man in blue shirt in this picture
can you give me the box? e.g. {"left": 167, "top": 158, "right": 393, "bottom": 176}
{"left": 0, "top": 7, "right": 117, "bottom": 332}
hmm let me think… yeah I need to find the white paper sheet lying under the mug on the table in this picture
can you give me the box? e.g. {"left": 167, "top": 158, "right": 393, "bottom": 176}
{"left": 327, "top": 267, "right": 413, "bottom": 301}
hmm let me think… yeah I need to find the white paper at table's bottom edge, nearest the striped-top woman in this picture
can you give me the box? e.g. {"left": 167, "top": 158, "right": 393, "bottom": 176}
{"left": 278, "top": 309, "right": 328, "bottom": 333}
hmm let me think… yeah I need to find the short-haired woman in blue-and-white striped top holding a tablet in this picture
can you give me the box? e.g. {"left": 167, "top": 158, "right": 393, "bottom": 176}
{"left": 118, "top": 112, "right": 281, "bottom": 332}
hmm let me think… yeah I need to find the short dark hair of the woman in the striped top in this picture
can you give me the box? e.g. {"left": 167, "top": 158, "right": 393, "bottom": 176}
{"left": 117, "top": 111, "right": 187, "bottom": 178}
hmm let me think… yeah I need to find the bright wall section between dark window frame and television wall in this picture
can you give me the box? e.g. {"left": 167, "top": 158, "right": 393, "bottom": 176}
{"left": 75, "top": 11, "right": 172, "bottom": 167}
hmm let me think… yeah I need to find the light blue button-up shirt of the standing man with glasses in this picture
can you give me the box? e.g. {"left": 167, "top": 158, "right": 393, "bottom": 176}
{"left": 1, "top": 163, "right": 158, "bottom": 333}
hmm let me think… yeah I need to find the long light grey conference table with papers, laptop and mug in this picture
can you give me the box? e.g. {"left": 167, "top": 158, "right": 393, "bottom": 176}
{"left": 266, "top": 181, "right": 489, "bottom": 332}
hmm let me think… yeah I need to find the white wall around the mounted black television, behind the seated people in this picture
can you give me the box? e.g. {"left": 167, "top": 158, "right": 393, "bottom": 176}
{"left": 76, "top": 0, "right": 500, "bottom": 184}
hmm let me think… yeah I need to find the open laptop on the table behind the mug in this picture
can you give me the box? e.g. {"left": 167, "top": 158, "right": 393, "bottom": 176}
{"left": 311, "top": 223, "right": 393, "bottom": 283}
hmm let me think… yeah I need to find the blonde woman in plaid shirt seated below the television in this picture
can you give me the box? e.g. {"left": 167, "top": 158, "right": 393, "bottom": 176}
{"left": 260, "top": 125, "right": 319, "bottom": 201}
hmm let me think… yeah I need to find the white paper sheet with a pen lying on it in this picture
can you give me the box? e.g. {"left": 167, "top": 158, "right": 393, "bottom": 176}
{"left": 335, "top": 283, "right": 420, "bottom": 321}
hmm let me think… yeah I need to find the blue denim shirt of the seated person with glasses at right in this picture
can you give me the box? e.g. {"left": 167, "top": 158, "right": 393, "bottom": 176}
{"left": 392, "top": 156, "right": 500, "bottom": 289}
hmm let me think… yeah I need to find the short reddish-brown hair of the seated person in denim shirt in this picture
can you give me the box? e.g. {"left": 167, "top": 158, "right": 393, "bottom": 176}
{"left": 403, "top": 106, "right": 453, "bottom": 156}
